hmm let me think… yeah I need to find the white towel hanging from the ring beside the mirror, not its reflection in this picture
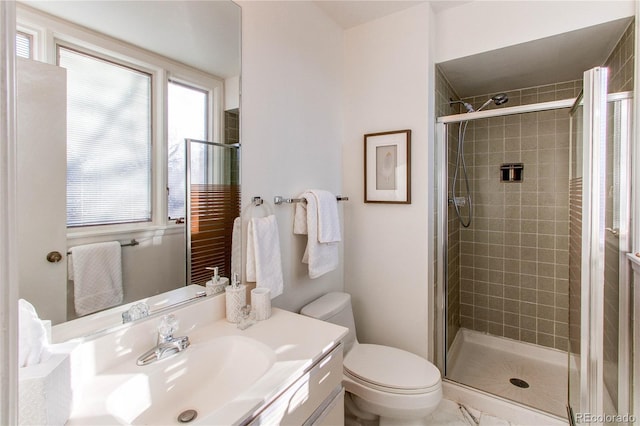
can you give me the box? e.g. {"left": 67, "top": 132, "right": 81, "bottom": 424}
{"left": 246, "top": 215, "right": 284, "bottom": 299}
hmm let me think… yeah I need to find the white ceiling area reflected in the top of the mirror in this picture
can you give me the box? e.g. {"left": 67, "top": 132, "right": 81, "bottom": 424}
{"left": 20, "top": 0, "right": 240, "bottom": 78}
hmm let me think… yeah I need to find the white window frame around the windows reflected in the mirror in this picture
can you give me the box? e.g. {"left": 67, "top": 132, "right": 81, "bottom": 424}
{"left": 17, "top": 5, "right": 224, "bottom": 243}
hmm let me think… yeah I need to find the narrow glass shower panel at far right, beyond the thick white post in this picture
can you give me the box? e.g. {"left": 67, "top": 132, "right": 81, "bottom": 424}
{"left": 603, "top": 93, "right": 632, "bottom": 424}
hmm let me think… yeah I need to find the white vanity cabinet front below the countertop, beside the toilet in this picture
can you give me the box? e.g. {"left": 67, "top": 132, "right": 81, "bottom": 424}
{"left": 245, "top": 344, "right": 344, "bottom": 426}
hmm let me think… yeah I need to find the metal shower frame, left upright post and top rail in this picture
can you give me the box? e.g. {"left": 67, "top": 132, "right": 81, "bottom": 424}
{"left": 434, "top": 98, "right": 576, "bottom": 380}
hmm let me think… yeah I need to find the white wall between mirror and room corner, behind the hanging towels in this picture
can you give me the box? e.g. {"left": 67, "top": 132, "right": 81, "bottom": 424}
{"left": 239, "top": 1, "right": 344, "bottom": 311}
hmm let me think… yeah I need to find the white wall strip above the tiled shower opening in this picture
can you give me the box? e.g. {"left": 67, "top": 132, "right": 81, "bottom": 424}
{"left": 435, "top": 0, "right": 636, "bottom": 63}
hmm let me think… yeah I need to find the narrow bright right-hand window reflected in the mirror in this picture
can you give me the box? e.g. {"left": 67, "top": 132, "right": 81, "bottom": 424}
{"left": 167, "top": 81, "right": 209, "bottom": 219}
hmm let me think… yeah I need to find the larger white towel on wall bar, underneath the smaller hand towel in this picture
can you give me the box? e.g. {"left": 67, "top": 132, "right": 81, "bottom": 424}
{"left": 293, "top": 191, "right": 340, "bottom": 278}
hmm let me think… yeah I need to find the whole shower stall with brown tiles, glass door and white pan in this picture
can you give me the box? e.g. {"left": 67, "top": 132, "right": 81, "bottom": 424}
{"left": 435, "top": 67, "right": 631, "bottom": 424}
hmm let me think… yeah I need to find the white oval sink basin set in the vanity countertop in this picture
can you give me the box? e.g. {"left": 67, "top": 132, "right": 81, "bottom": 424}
{"left": 101, "top": 336, "right": 276, "bottom": 425}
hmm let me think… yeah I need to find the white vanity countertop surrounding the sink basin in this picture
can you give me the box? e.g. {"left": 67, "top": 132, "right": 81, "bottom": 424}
{"left": 67, "top": 301, "right": 347, "bottom": 425}
